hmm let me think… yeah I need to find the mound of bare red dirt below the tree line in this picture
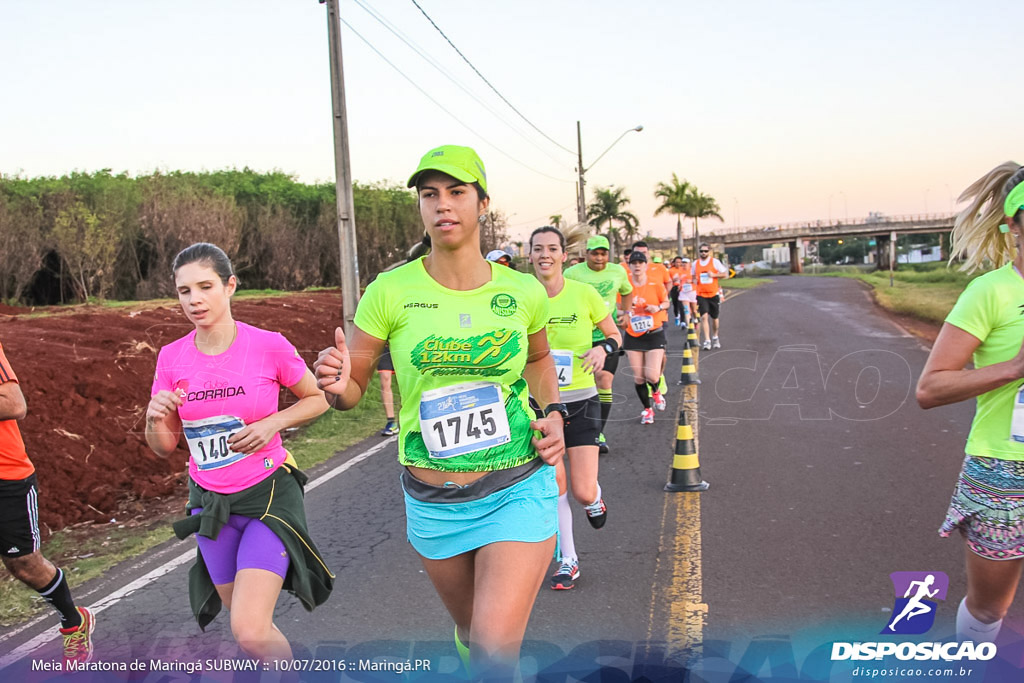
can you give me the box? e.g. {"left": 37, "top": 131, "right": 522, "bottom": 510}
{"left": 0, "top": 292, "right": 341, "bottom": 532}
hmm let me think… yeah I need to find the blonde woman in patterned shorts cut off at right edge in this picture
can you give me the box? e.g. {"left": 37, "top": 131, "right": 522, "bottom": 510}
{"left": 918, "top": 162, "right": 1024, "bottom": 643}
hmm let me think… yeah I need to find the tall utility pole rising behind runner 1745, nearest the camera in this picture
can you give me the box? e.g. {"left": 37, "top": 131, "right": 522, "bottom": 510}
{"left": 321, "top": 0, "right": 359, "bottom": 339}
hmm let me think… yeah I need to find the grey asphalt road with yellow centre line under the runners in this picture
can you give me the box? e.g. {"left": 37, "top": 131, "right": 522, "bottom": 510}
{"left": 0, "top": 278, "right": 1024, "bottom": 681}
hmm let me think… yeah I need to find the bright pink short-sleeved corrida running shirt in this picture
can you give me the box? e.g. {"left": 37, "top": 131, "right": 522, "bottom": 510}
{"left": 152, "top": 322, "right": 306, "bottom": 494}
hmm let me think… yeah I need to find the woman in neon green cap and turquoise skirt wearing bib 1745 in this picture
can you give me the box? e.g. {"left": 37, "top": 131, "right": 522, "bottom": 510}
{"left": 313, "top": 145, "right": 565, "bottom": 678}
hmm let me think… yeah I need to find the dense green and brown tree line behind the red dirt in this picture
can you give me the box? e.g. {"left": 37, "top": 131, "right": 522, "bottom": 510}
{"left": 0, "top": 168, "right": 507, "bottom": 305}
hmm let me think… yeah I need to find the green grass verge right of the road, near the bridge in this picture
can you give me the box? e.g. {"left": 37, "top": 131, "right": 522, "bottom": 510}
{"left": 804, "top": 263, "right": 983, "bottom": 323}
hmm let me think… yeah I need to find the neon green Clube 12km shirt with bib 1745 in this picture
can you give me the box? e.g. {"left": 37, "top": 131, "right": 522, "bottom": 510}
{"left": 355, "top": 258, "right": 548, "bottom": 472}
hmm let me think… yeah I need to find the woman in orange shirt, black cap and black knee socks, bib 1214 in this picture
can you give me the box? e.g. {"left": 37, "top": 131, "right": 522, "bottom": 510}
{"left": 623, "top": 250, "right": 670, "bottom": 425}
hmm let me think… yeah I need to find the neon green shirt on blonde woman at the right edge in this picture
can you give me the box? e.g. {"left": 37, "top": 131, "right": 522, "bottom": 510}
{"left": 946, "top": 263, "right": 1024, "bottom": 461}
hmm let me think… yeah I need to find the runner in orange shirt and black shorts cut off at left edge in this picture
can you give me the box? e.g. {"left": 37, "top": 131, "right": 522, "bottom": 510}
{"left": 0, "top": 345, "right": 95, "bottom": 669}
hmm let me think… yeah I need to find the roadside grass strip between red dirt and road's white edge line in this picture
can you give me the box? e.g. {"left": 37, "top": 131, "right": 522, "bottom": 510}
{"left": 0, "top": 373, "right": 401, "bottom": 627}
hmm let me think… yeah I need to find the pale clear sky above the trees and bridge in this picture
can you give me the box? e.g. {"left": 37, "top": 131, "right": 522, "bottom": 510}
{"left": 0, "top": 0, "right": 1024, "bottom": 242}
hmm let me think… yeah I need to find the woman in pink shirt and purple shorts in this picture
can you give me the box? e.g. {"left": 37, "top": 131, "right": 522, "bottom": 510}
{"left": 145, "top": 243, "right": 325, "bottom": 661}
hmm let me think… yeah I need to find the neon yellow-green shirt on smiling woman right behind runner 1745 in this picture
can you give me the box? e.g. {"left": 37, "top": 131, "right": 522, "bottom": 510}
{"left": 547, "top": 280, "right": 608, "bottom": 403}
